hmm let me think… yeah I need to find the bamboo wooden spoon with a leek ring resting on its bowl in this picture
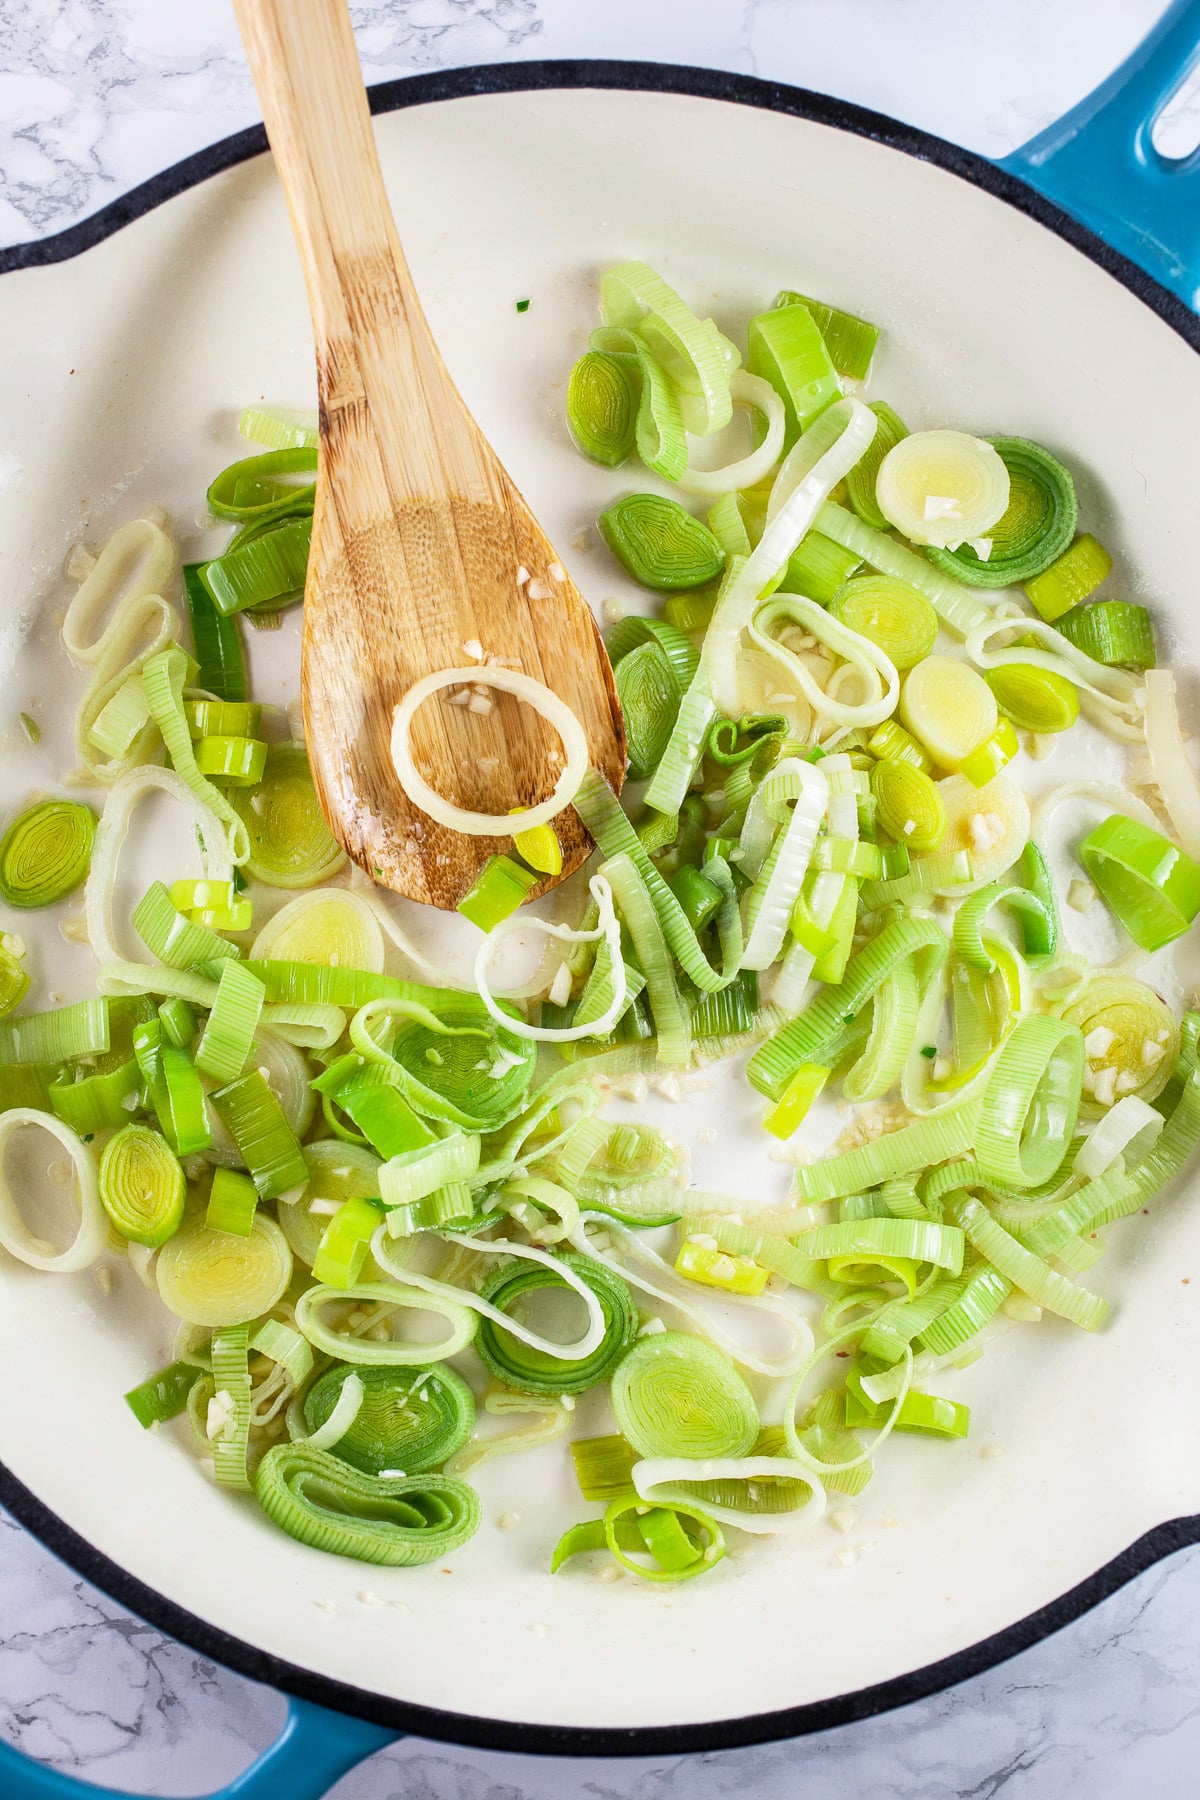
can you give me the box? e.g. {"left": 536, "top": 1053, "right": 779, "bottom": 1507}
{"left": 234, "top": 0, "right": 624, "bottom": 907}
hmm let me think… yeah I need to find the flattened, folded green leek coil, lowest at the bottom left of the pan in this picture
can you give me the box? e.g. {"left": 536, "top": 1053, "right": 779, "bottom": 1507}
{"left": 254, "top": 1444, "right": 482, "bottom": 1568}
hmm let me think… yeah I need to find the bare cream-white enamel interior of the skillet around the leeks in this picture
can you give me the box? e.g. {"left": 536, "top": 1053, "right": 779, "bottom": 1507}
{"left": 0, "top": 65, "right": 1200, "bottom": 1751}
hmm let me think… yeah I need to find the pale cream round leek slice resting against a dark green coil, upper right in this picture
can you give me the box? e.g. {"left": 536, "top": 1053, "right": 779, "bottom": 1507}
{"left": 874, "top": 430, "right": 1009, "bottom": 549}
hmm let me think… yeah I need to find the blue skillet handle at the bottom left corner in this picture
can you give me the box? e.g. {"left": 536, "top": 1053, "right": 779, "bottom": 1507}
{"left": 0, "top": 1699, "right": 396, "bottom": 1800}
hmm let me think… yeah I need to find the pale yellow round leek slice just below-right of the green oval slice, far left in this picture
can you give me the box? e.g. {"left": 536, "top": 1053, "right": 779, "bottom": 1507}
{"left": 155, "top": 1213, "right": 291, "bottom": 1328}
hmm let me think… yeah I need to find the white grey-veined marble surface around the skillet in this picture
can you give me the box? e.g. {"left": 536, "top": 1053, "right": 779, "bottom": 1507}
{"left": 0, "top": 0, "right": 1200, "bottom": 1800}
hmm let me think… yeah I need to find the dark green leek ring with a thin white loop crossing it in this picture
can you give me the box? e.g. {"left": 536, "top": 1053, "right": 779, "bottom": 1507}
{"left": 475, "top": 1251, "right": 637, "bottom": 1393}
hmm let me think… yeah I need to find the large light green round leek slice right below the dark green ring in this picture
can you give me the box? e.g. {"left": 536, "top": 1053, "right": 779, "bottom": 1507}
{"left": 612, "top": 1332, "right": 759, "bottom": 1462}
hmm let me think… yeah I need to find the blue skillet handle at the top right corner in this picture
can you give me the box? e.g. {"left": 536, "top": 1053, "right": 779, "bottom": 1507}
{"left": 1000, "top": 0, "right": 1200, "bottom": 311}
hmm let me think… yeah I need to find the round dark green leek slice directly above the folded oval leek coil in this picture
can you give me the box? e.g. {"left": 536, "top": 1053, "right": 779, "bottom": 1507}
{"left": 304, "top": 1363, "right": 475, "bottom": 1476}
